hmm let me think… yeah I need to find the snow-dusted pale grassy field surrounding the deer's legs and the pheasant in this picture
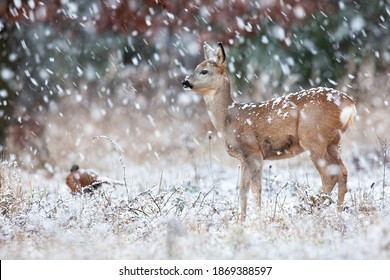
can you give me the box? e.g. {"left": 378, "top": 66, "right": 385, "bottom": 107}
{"left": 0, "top": 93, "right": 390, "bottom": 259}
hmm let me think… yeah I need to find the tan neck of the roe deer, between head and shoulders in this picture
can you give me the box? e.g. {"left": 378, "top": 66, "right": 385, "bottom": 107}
{"left": 203, "top": 74, "right": 234, "bottom": 132}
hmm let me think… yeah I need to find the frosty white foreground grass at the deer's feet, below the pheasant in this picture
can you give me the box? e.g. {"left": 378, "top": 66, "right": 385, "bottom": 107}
{"left": 0, "top": 140, "right": 390, "bottom": 259}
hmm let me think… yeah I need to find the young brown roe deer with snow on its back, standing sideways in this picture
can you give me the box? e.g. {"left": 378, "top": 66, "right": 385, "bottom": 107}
{"left": 182, "top": 43, "right": 356, "bottom": 222}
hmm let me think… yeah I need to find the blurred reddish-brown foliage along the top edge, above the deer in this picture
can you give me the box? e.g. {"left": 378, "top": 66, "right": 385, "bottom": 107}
{"left": 0, "top": 0, "right": 337, "bottom": 41}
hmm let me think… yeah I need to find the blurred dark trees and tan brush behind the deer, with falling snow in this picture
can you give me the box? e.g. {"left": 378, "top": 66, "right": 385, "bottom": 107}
{"left": 0, "top": 0, "right": 390, "bottom": 173}
